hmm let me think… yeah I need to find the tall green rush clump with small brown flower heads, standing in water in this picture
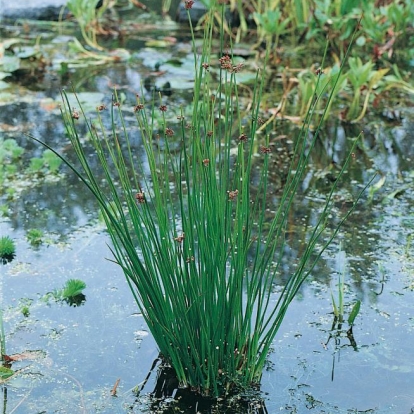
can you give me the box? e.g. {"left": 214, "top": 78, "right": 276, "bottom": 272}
{"left": 30, "top": 2, "right": 370, "bottom": 397}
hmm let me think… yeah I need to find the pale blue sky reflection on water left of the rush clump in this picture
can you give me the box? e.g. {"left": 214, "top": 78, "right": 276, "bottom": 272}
{"left": 2, "top": 227, "right": 157, "bottom": 413}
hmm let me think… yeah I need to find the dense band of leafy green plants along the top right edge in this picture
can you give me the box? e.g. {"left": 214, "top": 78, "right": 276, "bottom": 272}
{"left": 213, "top": 0, "right": 414, "bottom": 59}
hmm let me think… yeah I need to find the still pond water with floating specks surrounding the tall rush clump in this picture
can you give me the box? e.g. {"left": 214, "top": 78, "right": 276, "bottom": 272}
{"left": 0, "top": 1, "right": 414, "bottom": 414}
